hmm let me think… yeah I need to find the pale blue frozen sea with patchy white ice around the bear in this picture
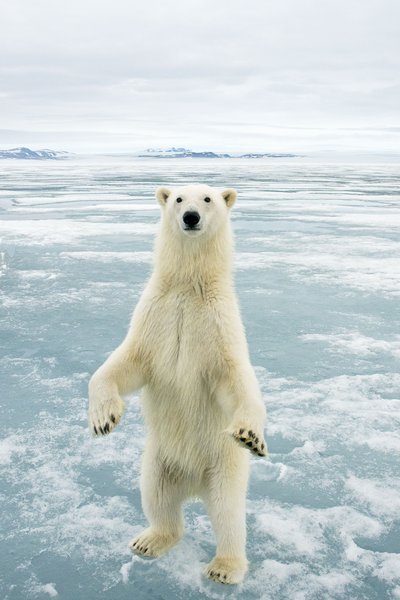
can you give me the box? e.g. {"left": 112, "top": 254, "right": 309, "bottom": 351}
{"left": 0, "top": 158, "right": 400, "bottom": 600}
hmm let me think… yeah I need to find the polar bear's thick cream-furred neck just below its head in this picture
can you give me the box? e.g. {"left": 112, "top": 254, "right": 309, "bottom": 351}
{"left": 154, "top": 223, "right": 233, "bottom": 289}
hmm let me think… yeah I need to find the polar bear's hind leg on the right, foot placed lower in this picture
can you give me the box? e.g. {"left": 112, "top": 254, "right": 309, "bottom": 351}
{"left": 202, "top": 450, "right": 248, "bottom": 583}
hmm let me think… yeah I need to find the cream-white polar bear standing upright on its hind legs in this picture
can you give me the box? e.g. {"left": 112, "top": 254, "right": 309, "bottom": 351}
{"left": 89, "top": 185, "right": 266, "bottom": 583}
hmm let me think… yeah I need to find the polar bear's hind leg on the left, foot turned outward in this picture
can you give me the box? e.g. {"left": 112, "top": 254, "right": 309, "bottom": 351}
{"left": 129, "top": 451, "right": 188, "bottom": 558}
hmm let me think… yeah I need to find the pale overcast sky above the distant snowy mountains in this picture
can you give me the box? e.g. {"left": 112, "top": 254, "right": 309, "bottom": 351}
{"left": 0, "top": 0, "right": 400, "bottom": 152}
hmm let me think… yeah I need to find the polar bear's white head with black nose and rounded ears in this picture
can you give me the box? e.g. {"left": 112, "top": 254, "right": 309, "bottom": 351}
{"left": 156, "top": 185, "right": 237, "bottom": 238}
